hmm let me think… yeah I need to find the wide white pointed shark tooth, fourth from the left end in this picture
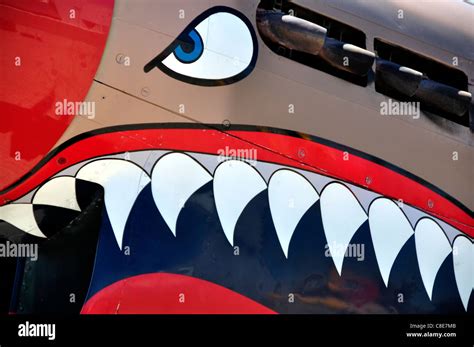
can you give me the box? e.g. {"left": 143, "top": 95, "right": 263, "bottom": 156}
{"left": 151, "top": 153, "right": 212, "bottom": 236}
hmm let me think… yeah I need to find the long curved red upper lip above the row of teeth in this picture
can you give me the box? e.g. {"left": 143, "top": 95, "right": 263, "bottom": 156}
{"left": 0, "top": 124, "right": 474, "bottom": 237}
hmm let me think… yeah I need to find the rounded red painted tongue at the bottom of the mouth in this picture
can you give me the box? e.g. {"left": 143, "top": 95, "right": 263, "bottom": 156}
{"left": 81, "top": 273, "right": 276, "bottom": 314}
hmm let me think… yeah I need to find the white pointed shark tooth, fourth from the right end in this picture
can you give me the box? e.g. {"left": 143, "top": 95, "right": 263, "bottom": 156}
{"left": 321, "top": 182, "right": 367, "bottom": 275}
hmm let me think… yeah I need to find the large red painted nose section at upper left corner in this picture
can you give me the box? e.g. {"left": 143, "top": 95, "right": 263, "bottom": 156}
{"left": 0, "top": 0, "right": 114, "bottom": 189}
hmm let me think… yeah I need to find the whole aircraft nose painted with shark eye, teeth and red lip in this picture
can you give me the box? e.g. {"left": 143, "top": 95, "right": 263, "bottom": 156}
{"left": 0, "top": 0, "right": 474, "bottom": 346}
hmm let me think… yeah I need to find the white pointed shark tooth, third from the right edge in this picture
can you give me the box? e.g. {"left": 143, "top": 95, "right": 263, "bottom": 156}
{"left": 369, "top": 198, "right": 413, "bottom": 287}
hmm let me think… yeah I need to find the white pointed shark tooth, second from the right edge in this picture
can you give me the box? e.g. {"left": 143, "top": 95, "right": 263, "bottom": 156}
{"left": 415, "top": 218, "right": 451, "bottom": 300}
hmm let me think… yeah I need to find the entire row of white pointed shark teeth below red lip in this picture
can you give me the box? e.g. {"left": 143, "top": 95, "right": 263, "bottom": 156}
{"left": 0, "top": 153, "right": 474, "bottom": 310}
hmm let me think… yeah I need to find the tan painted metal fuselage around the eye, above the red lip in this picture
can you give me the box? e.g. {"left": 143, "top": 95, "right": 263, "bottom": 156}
{"left": 65, "top": 0, "right": 474, "bottom": 210}
